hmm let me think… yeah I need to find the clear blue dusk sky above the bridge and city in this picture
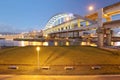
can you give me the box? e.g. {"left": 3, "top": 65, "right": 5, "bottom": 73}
{"left": 0, "top": 0, "right": 120, "bottom": 32}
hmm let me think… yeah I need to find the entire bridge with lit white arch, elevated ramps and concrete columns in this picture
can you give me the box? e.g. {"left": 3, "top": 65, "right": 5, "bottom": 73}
{"left": 44, "top": 2, "right": 120, "bottom": 47}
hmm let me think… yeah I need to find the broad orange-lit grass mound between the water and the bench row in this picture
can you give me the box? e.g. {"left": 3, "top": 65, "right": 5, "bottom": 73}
{"left": 0, "top": 46, "right": 120, "bottom": 65}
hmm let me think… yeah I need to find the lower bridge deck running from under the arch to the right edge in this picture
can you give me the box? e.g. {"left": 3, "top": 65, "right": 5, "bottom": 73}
{"left": 46, "top": 20, "right": 120, "bottom": 34}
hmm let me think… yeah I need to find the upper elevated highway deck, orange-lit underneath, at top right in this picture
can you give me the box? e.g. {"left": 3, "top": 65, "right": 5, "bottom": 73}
{"left": 85, "top": 2, "right": 120, "bottom": 21}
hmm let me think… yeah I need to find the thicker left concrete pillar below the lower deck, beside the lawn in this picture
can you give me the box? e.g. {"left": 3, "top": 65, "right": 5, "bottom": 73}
{"left": 96, "top": 28, "right": 104, "bottom": 47}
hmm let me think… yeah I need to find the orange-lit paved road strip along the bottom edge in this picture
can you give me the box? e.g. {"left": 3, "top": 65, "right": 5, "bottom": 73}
{"left": 0, "top": 75, "right": 120, "bottom": 80}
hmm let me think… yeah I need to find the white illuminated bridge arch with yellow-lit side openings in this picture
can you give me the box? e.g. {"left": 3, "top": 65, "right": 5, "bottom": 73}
{"left": 44, "top": 13, "right": 95, "bottom": 35}
